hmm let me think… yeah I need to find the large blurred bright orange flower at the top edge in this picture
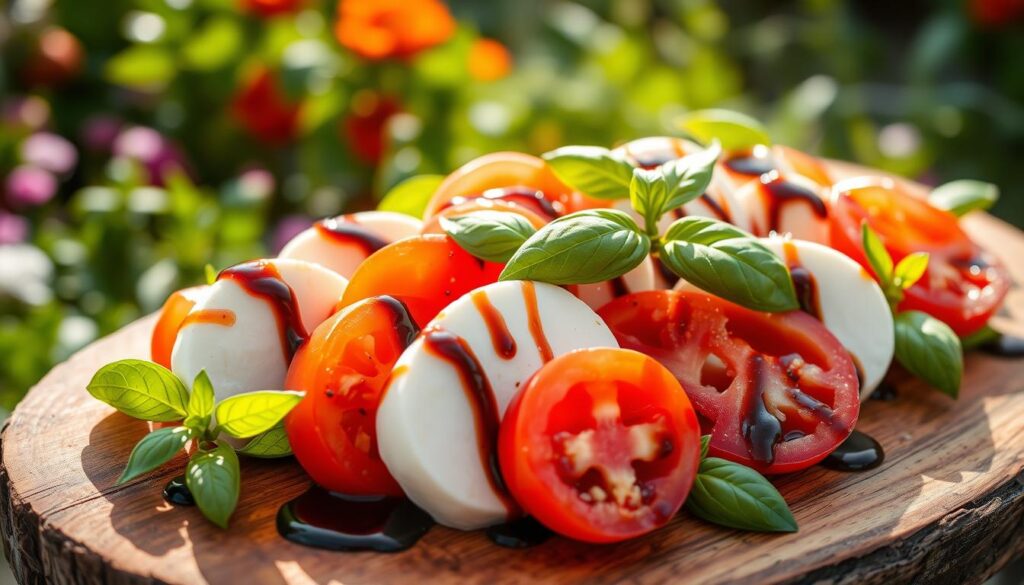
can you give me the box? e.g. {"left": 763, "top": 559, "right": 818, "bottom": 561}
{"left": 334, "top": 0, "right": 456, "bottom": 60}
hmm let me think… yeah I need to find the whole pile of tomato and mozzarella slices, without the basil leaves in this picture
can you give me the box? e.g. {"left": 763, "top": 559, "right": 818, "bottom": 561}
{"left": 153, "top": 138, "right": 1007, "bottom": 542}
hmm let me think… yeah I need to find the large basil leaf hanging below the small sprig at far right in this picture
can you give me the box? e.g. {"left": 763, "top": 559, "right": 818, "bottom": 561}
{"left": 894, "top": 310, "right": 964, "bottom": 399}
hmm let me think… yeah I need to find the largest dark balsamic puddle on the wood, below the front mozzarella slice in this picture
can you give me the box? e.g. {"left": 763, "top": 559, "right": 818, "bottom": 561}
{"left": 276, "top": 486, "right": 434, "bottom": 552}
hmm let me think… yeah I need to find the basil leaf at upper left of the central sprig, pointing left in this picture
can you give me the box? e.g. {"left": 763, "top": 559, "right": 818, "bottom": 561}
{"left": 543, "top": 147, "right": 633, "bottom": 199}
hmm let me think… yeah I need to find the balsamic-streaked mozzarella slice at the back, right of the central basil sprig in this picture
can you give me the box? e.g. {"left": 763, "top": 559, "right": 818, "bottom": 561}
{"left": 736, "top": 171, "right": 828, "bottom": 244}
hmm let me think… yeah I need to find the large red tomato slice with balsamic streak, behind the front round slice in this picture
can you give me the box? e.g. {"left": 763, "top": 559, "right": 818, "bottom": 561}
{"left": 598, "top": 291, "right": 860, "bottom": 473}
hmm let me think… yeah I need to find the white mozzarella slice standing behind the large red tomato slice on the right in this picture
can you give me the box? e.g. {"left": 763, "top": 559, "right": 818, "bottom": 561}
{"left": 676, "top": 238, "right": 895, "bottom": 401}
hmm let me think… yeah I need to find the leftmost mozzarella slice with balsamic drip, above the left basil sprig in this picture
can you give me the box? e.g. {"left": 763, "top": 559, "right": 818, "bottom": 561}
{"left": 171, "top": 259, "right": 348, "bottom": 400}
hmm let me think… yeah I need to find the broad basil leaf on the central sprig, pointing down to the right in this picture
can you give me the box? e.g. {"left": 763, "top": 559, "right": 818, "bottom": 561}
{"left": 660, "top": 216, "right": 800, "bottom": 312}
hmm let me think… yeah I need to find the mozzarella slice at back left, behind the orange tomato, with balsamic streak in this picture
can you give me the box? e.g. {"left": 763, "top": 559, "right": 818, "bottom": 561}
{"left": 278, "top": 211, "right": 423, "bottom": 279}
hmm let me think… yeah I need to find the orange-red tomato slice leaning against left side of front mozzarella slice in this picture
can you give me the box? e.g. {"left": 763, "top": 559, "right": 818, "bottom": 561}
{"left": 285, "top": 296, "right": 419, "bottom": 496}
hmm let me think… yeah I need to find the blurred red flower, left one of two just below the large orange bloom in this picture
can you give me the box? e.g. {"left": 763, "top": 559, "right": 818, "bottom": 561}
{"left": 231, "top": 67, "right": 299, "bottom": 144}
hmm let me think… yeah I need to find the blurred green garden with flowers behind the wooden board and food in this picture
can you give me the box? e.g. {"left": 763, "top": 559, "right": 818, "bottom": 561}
{"left": 0, "top": 0, "right": 1024, "bottom": 414}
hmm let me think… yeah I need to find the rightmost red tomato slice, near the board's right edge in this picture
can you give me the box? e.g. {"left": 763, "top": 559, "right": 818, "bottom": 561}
{"left": 830, "top": 178, "right": 1010, "bottom": 336}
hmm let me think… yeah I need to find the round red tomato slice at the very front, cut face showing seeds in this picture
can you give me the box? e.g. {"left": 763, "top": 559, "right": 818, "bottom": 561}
{"left": 498, "top": 347, "right": 700, "bottom": 542}
